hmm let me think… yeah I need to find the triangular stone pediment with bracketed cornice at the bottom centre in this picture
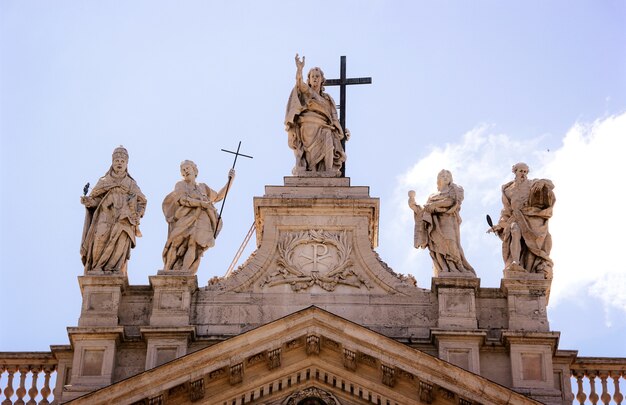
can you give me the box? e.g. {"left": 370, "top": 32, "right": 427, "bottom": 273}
{"left": 67, "top": 307, "right": 537, "bottom": 405}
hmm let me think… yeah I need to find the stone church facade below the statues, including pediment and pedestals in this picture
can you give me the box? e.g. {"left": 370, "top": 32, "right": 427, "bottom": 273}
{"left": 37, "top": 177, "right": 572, "bottom": 404}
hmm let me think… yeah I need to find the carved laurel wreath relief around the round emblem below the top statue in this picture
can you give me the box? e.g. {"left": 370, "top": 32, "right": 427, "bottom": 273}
{"left": 261, "top": 230, "right": 369, "bottom": 291}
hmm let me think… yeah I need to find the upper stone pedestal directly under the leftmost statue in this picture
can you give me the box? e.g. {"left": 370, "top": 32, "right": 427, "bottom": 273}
{"left": 78, "top": 275, "right": 128, "bottom": 327}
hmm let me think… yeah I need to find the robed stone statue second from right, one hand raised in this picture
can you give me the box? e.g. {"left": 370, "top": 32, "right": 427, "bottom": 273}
{"left": 409, "top": 170, "right": 476, "bottom": 277}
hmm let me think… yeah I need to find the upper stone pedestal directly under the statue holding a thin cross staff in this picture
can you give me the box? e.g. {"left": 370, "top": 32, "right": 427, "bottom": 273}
{"left": 150, "top": 271, "right": 198, "bottom": 327}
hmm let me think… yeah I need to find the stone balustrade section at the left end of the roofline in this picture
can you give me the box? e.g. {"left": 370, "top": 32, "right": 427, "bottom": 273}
{"left": 0, "top": 352, "right": 58, "bottom": 405}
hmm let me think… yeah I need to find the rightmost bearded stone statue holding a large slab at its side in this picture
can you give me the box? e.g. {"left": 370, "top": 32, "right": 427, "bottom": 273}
{"left": 487, "top": 163, "right": 556, "bottom": 279}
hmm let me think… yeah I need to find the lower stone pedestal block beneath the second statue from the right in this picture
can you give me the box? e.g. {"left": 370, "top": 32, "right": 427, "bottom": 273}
{"left": 431, "top": 329, "right": 487, "bottom": 374}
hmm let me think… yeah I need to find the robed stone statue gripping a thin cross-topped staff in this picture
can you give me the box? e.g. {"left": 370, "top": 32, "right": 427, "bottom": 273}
{"left": 163, "top": 160, "right": 235, "bottom": 273}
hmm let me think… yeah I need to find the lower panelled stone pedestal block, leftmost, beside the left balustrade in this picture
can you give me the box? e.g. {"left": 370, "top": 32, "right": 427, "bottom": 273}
{"left": 63, "top": 326, "right": 124, "bottom": 401}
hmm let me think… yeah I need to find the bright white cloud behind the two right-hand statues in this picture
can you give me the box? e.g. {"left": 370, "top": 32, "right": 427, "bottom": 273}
{"left": 381, "top": 114, "right": 626, "bottom": 322}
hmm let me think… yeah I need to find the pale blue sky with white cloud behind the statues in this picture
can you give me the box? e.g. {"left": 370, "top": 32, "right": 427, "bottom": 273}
{"left": 0, "top": 0, "right": 626, "bottom": 357}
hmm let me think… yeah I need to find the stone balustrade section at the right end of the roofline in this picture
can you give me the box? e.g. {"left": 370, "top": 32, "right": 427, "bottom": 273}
{"left": 570, "top": 357, "right": 626, "bottom": 405}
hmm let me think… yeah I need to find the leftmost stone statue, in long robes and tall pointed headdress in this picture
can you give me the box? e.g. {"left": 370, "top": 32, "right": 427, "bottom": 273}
{"left": 80, "top": 146, "right": 147, "bottom": 274}
